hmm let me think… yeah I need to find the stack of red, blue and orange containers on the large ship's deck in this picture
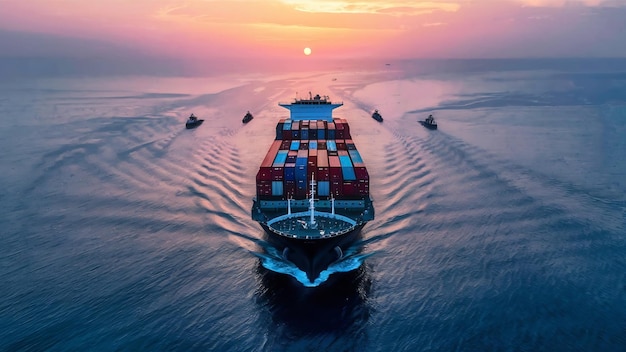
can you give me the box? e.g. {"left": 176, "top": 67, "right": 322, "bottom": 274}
{"left": 256, "top": 118, "right": 369, "bottom": 200}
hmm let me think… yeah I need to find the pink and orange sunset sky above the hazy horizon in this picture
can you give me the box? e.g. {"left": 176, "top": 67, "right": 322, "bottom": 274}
{"left": 0, "top": 0, "right": 626, "bottom": 73}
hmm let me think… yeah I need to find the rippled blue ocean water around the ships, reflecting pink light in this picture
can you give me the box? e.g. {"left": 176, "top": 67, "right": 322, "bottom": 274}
{"left": 0, "top": 60, "right": 626, "bottom": 351}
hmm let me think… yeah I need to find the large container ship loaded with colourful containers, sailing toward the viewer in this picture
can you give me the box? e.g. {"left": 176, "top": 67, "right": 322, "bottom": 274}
{"left": 252, "top": 93, "right": 374, "bottom": 280}
